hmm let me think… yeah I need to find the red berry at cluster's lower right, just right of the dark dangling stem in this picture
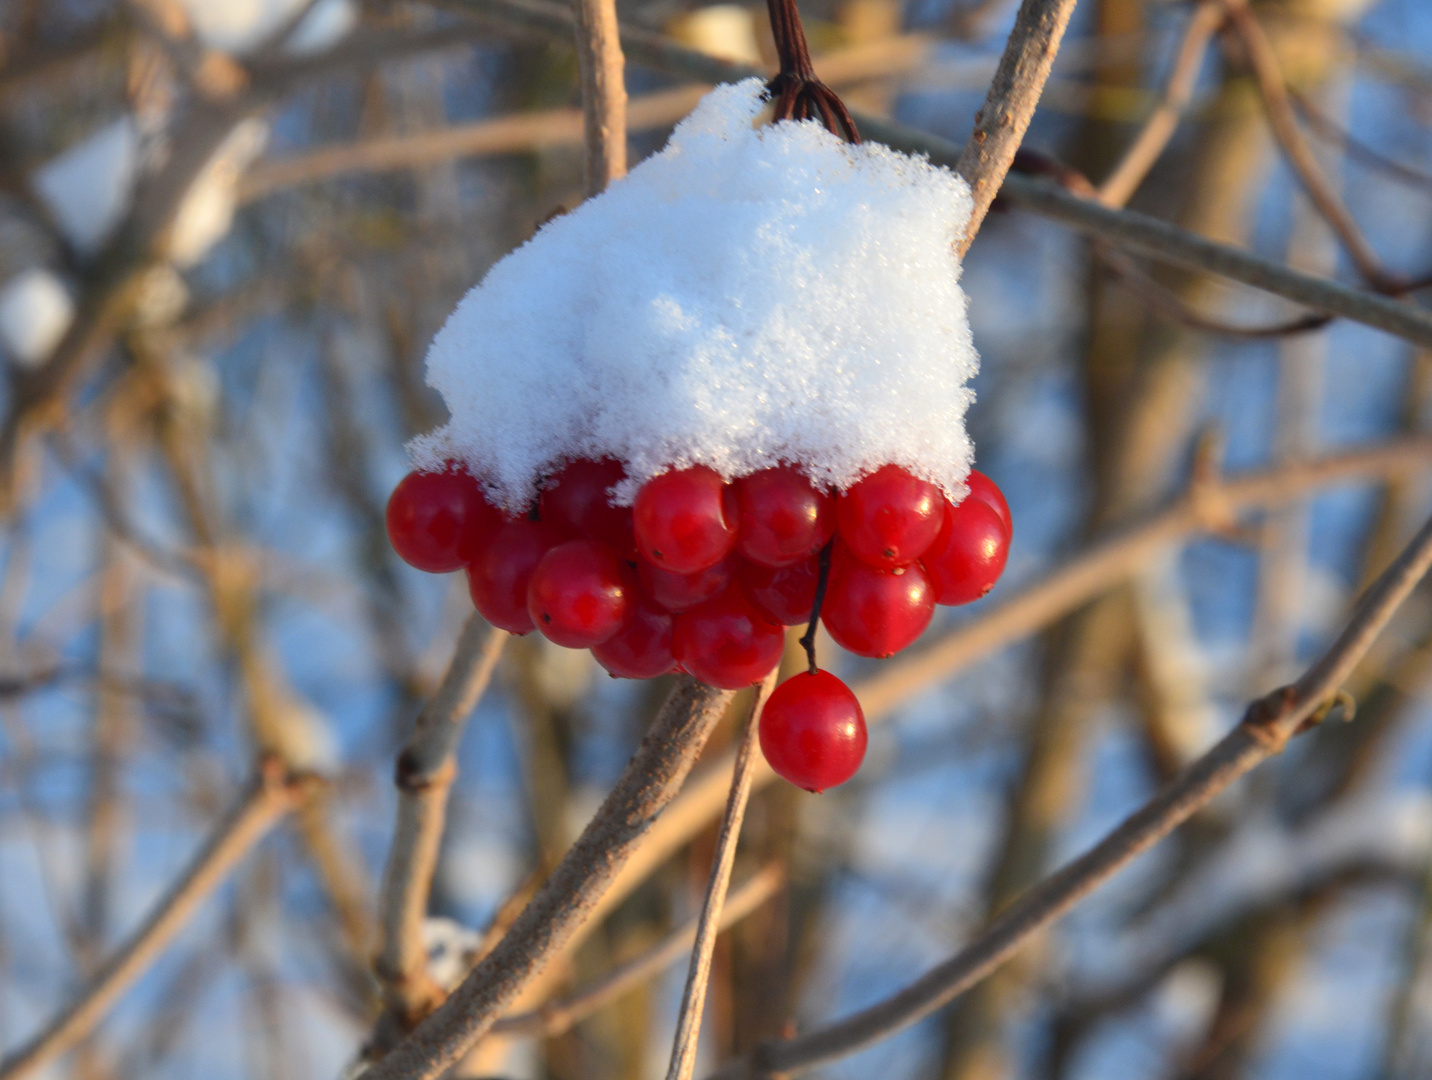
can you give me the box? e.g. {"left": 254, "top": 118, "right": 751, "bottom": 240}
{"left": 821, "top": 544, "right": 935, "bottom": 656}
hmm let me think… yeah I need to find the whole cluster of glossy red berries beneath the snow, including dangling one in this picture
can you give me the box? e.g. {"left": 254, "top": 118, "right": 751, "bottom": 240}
{"left": 388, "top": 460, "right": 1010, "bottom": 791}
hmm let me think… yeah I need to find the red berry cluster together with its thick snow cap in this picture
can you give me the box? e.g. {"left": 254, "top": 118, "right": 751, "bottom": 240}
{"left": 388, "top": 80, "right": 1010, "bottom": 791}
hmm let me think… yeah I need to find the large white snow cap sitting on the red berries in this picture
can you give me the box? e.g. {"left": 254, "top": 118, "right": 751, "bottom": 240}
{"left": 410, "top": 79, "right": 978, "bottom": 510}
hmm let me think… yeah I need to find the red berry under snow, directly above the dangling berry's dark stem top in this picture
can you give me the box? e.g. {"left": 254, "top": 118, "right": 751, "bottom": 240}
{"left": 732, "top": 466, "right": 835, "bottom": 566}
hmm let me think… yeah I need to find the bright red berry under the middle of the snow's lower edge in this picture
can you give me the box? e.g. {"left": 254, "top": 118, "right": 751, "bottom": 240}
{"left": 632, "top": 466, "right": 740, "bottom": 574}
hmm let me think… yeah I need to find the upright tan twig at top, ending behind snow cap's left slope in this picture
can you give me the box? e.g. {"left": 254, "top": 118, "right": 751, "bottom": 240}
{"left": 571, "top": 0, "right": 626, "bottom": 198}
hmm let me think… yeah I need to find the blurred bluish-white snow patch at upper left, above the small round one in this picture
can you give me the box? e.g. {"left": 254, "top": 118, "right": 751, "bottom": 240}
{"left": 32, "top": 116, "right": 139, "bottom": 255}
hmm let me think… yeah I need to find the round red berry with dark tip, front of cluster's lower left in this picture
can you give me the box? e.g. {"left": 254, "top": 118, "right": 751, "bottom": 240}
{"left": 527, "top": 540, "right": 634, "bottom": 649}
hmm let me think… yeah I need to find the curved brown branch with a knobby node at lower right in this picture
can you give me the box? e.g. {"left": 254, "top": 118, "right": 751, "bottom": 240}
{"left": 719, "top": 507, "right": 1432, "bottom": 1077}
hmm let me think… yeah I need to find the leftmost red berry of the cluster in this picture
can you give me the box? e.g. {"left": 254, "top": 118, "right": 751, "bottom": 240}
{"left": 385, "top": 467, "right": 503, "bottom": 574}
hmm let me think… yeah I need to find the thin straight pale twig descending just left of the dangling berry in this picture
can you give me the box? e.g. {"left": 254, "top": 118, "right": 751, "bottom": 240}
{"left": 666, "top": 667, "right": 780, "bottom": 1080}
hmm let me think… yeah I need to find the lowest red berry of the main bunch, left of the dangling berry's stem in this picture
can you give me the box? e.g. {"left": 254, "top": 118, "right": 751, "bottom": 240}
{"left": 672, "top": 589, "right": 786, "bottom": 690}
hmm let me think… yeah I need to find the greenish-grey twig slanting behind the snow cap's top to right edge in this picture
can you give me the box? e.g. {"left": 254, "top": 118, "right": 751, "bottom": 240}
{"left": 430, "top": 0, "right": 1432, "bottom": 345}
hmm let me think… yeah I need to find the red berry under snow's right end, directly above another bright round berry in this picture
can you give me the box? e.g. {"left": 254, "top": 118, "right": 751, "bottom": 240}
{"left": 836, "top": 466, "right": 945, "bottom": 570}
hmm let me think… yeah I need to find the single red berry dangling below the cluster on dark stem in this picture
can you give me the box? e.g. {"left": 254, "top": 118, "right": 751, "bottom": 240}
{"left": 760, "top": 672, "right": 865, "bottom": 792}
